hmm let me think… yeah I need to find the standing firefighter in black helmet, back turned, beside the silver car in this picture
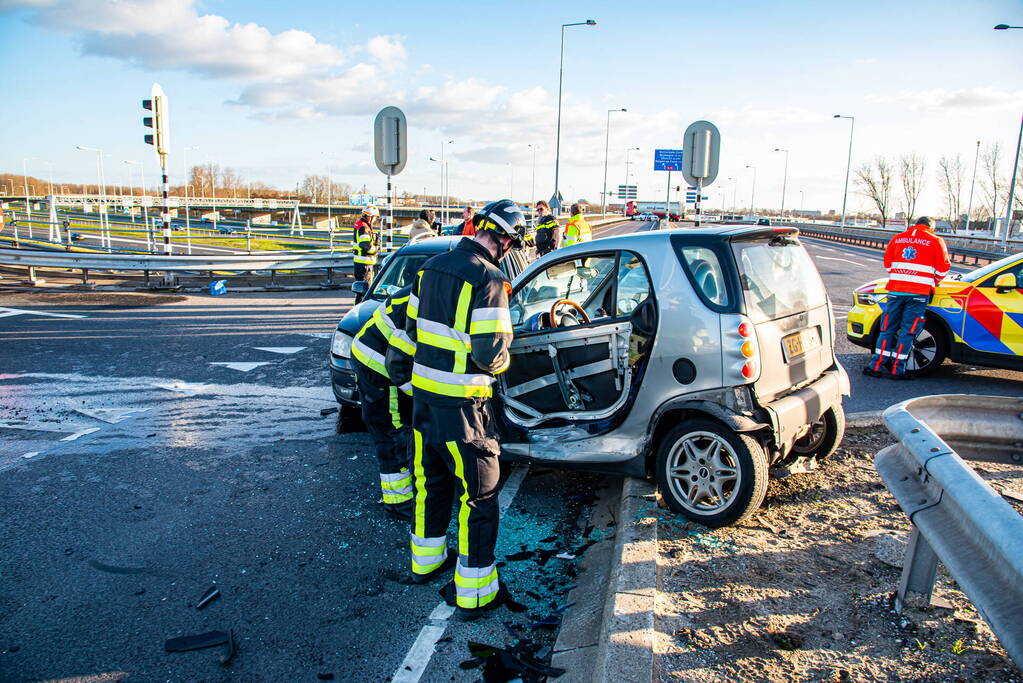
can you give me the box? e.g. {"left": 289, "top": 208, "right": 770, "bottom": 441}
{"left": 387, "top": 199, "right": 526, "bottom": 619}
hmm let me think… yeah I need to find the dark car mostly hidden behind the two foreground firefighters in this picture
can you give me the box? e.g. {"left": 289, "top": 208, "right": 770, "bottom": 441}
{"left": 330, "top": 237, "right": 529, "bottom": 426}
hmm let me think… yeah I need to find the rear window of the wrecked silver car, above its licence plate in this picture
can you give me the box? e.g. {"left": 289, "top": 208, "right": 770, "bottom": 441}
{"left": 731, "top": 235, "right": 827, "bottom": 322}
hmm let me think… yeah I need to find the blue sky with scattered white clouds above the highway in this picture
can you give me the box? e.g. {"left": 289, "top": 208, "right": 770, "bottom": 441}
{"left": 0, "top": 0, "right": 1023, "bottom": 214}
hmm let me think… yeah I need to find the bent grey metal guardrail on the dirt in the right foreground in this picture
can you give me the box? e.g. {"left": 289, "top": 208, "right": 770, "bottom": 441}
{"left": 874, "top": 395, "right": 1023, "bottom": 667}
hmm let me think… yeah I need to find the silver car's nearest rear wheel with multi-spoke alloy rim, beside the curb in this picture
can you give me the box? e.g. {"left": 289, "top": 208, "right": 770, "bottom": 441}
{"left": 657, "top": 419, "right": 768, "bottom": 527}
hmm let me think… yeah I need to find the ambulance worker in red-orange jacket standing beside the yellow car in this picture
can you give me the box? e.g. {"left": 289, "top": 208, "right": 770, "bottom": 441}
{"left": 863, "top": 216, "right": 951, "bottom": 379}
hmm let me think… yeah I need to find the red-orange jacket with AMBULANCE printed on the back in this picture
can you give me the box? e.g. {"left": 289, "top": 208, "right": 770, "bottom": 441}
{"left": 885, "top": 225, "right": 951, "bottom": 294}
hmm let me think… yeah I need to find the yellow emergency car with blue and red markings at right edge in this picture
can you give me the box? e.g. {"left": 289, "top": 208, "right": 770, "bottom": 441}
{"left": 846, "top": 249, "right": 1023, "bottom": 376}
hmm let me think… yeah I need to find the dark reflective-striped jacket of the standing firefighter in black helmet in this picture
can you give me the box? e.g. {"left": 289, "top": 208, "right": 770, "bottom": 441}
{"left": 396, "top": 237, "right": 512, "bottom": 406}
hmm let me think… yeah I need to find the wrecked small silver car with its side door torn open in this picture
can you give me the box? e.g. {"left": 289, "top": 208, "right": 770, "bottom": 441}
{"left": 497, "top": 226, "right": 849, "bottom": 527}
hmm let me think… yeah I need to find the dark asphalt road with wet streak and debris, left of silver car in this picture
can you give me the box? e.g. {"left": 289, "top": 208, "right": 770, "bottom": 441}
{"left": 0, "top": 291, "right": 607, "bottom": 682}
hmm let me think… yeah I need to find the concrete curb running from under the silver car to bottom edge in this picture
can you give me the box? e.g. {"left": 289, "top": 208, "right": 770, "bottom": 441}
{"left": 592, "top": 477, "right": 658, "bottom": 683}
